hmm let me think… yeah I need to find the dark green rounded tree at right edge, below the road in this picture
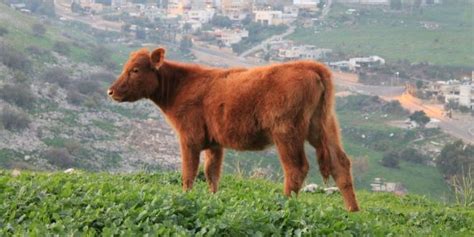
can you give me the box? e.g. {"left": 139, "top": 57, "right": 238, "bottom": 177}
{"left": 436, "top": 140, "right": 474, "bottom": 177}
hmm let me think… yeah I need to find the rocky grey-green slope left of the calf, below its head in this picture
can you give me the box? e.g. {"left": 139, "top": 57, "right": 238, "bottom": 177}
{"left": 0, "top": 54, "right": 179, "bottom": 172}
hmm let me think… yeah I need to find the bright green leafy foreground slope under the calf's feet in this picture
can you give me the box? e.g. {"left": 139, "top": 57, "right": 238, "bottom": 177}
{"left": 0, "top": 171, "right": 474, "bottom": 236}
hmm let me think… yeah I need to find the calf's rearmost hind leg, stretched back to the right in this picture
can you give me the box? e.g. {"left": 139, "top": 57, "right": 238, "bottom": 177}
{"left": 308, "top": 116, "right": 359, "bottom": 211}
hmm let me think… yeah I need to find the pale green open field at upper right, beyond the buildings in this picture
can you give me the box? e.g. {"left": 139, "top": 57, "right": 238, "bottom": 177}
{"left": 289, "top": 1, "right": 474, "bottom": 67}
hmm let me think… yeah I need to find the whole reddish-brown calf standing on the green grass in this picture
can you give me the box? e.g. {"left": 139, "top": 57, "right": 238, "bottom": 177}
{"left": 108, "top": 48, "right": 359, "bottom": 211}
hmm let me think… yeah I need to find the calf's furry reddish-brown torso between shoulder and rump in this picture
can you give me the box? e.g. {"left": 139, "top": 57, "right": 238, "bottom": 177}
{"left": 203, "top": 62, "right": 321, "bottom": 150}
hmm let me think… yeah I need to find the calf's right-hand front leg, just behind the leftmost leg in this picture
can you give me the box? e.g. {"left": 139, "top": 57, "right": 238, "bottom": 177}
{"left": 204, "top": 147, "right": 224, "bottom": 193}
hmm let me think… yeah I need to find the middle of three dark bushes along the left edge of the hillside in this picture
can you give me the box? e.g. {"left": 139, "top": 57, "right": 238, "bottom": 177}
{"left": 0, "top": 84, "right": 35, "bottom": 109}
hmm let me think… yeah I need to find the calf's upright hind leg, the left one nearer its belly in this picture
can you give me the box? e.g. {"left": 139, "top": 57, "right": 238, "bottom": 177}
{"left": 273, "top": 131, "right": 309, "bottom": 196}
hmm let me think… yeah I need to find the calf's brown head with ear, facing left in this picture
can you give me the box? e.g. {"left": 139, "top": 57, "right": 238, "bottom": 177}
{"left": 107, "top": 48, "right": 165, "bottom": 102}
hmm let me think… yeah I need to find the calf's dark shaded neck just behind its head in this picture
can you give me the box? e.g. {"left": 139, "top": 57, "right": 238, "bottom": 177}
{"left": 150, "top": 61, "right": 193, "bottom": 111}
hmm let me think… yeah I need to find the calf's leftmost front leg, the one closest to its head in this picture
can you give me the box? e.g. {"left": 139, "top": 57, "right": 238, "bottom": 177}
{"left": 181, "top": 144, "right": 201, "bottom": 191}
